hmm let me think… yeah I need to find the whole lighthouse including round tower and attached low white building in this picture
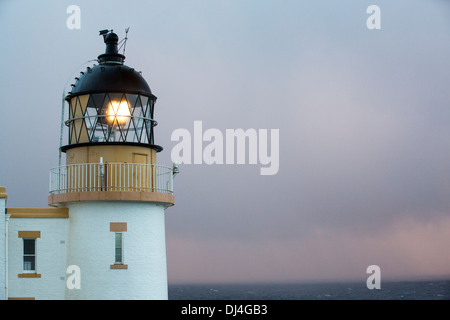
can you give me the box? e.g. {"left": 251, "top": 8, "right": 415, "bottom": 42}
{"left": 0, "top": 30, "right": 177, "bottom": 299}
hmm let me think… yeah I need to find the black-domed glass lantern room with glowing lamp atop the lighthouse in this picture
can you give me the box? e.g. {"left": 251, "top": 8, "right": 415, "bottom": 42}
{"left": 62, "top": 32, "right": 162, "bottom": 152}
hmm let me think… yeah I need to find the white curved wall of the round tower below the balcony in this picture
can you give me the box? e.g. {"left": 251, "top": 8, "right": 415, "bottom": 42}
{"left": 66, "top": 201, "right": 168, "bottom": 299}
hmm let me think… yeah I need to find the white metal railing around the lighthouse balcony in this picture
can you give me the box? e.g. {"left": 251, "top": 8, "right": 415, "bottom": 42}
{"left": 49, "top": 163, "right": 173, "bottom": 194}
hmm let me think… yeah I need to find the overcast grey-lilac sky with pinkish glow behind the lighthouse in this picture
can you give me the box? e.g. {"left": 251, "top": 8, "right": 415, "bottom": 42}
{"left": 0, "top": 0, "right": 450, "bottom": 283}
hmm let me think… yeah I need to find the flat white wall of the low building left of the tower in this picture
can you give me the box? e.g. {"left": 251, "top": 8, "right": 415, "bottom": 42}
{"left": 8, "top": 218, "right": 68, "bottom": 299}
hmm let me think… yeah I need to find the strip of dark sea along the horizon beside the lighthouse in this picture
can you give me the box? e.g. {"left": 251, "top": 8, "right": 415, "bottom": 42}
{"left": 169, "top": 280, "right": 450, "bottom": 300}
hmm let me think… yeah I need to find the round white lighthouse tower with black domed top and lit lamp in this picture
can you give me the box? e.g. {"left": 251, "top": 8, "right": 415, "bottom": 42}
{"left": 48, "top": 30, "right": 176, "bottom": 299}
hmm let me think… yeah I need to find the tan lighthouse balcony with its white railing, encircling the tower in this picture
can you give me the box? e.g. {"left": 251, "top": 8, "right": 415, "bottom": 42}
{"left": 49, "top": 163, "right": 174, "bottom": 205}
